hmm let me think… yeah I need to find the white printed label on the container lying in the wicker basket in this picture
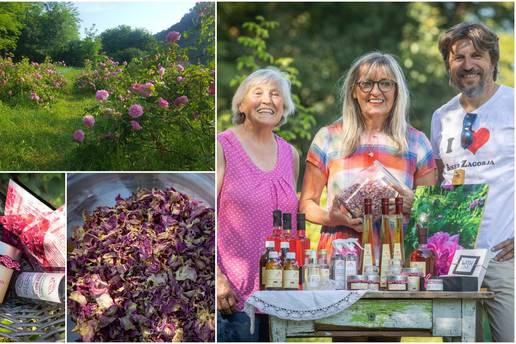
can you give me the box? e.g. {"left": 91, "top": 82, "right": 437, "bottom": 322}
{"left": 15, "top": 272, "right": 64, "bottom": 303}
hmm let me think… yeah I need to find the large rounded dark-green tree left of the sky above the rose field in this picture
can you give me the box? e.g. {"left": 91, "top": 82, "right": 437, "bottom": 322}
{"left": 15, "top": 2, "right": 79, "bottom": 62}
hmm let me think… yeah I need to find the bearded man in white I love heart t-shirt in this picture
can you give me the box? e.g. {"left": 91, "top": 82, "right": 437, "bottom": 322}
{"left": 431, "top": 23, "right": 514, "bottom": 342}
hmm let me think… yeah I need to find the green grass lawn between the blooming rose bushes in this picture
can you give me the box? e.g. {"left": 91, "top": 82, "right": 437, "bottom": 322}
{"left": 0, "top": 67, "right": 214, "bottom": 171}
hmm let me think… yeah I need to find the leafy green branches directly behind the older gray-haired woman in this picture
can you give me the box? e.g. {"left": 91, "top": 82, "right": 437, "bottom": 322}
{"left": 217, "top": 16, "right": 315, "bottom": 175}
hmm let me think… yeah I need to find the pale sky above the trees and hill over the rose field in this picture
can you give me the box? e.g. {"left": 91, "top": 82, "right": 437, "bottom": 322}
{"left": 74, "top": 1, "right": 196, "bottom": 38}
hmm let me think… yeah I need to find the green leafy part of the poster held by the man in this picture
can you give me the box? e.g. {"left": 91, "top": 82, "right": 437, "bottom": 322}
{"left": 405, "top": 184, "right": 489, "bottom": 260}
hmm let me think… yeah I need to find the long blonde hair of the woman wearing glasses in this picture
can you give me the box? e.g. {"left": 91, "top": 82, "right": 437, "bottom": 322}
{"left": 341, "top": 52, "right": 409, "bottom": 157}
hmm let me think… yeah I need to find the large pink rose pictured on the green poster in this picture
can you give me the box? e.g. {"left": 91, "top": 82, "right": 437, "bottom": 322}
{"left": 427, "top": 232, "right": 463, "bottom": 275}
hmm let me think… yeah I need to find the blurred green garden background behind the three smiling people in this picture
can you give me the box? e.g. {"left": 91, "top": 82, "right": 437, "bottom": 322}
{"left": 217, "top": 2, "right": 514, "bottom": 190}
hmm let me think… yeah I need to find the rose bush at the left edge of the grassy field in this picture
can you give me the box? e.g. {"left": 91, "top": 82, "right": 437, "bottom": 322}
{"left": 0, "top": 58, "right": 65, "bottom": 105}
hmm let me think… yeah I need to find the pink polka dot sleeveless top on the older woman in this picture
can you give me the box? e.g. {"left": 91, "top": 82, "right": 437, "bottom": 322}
{"left": 217, "top": 130, "right": 298, "bottom": 311}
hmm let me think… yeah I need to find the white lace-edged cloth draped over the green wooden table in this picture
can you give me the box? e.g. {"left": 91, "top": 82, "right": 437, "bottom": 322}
{"left": 244, "top": 290, "right": 367, "bottom": 333}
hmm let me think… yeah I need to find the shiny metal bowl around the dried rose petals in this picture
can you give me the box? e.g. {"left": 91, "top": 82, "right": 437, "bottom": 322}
{"left": 67, "top": 173, "right": 215, "bottom": 341}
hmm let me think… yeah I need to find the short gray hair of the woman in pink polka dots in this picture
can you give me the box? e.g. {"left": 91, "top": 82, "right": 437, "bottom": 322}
{"left": 231, "top": 67, "right": 295, "bottom": 126}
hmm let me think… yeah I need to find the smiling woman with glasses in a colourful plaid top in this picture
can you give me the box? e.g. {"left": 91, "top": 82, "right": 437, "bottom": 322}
{"left": 300, "top": 52, "right": 436, "bottom": 252}
